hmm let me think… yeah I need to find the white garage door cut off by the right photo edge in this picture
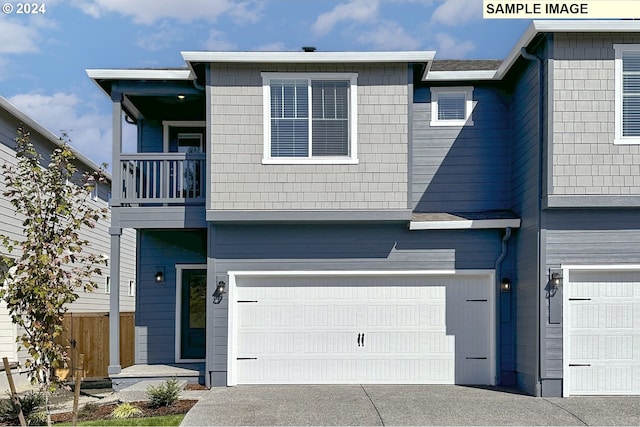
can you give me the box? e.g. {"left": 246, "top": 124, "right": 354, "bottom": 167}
{"left": 565, "top": 271, "right": 640, "bottom": 395}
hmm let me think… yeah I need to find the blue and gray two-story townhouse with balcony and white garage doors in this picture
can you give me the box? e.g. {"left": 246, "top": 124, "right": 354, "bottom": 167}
{"left": 88, "top": 21, "right": 640, "bottom": 396}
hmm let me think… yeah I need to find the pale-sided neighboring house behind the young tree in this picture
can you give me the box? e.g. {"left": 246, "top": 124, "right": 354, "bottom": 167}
{"left": 0, "top": 97, "right": 136, "bottom": 374}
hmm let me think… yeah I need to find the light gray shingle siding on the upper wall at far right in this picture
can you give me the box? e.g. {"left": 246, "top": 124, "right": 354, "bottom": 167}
{"left": 551, "top": 33, "right": 640, "bottom": 196}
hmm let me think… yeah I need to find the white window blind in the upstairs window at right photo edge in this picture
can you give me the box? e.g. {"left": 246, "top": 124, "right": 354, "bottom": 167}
{"left": 622, "top": 51, "right": 640, "bottom": 137}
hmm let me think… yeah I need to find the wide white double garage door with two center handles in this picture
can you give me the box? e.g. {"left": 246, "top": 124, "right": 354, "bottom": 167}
{"left": 229, "top": 276, "right": 494, "bottom": 384}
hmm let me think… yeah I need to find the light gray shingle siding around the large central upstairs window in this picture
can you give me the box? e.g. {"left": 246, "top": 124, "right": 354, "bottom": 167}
{"left": 208, "top": 64, "right": 408, "bottom": 211}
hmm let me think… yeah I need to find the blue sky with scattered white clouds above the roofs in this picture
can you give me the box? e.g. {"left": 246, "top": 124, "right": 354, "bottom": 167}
{"left": 0, "top": 0, "right": 530, "bottom": 171}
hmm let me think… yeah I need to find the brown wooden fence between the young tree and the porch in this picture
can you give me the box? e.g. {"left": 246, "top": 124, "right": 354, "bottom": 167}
{"left": 56, "top": 313, "right": 135, "bottom": 379}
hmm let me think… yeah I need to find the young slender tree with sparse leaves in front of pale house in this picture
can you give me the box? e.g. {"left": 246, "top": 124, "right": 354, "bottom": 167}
{"left": 0, "top": 127, "right": 107, "bottom": 424}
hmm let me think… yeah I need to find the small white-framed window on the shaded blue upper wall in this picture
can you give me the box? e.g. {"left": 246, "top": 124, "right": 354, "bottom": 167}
{"left": 431, "top": 87, "right": 473, "bottom": 126}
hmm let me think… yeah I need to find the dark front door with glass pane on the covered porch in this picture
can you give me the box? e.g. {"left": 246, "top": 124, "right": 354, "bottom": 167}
{"left": 179, "top": 269, "right": 207, "bottom": 360}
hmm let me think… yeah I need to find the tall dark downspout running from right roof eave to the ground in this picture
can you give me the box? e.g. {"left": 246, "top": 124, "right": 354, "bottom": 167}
{"left": 520, "top": 47, "right": 544, "bottom": 396}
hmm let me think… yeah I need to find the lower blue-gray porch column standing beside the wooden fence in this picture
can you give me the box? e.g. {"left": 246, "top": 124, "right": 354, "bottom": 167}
{"left": 107, "top": 227, "right": 122, "bottom": 375}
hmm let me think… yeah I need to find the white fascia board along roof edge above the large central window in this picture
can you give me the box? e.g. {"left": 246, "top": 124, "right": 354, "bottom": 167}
{"left": 182, "top": 51, "right": 435, "bottom": 64}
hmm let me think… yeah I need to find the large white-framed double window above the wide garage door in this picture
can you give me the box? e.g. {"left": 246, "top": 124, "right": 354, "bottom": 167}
{"left": 262, "top": 73, "right": 358, "bottom": 164}
